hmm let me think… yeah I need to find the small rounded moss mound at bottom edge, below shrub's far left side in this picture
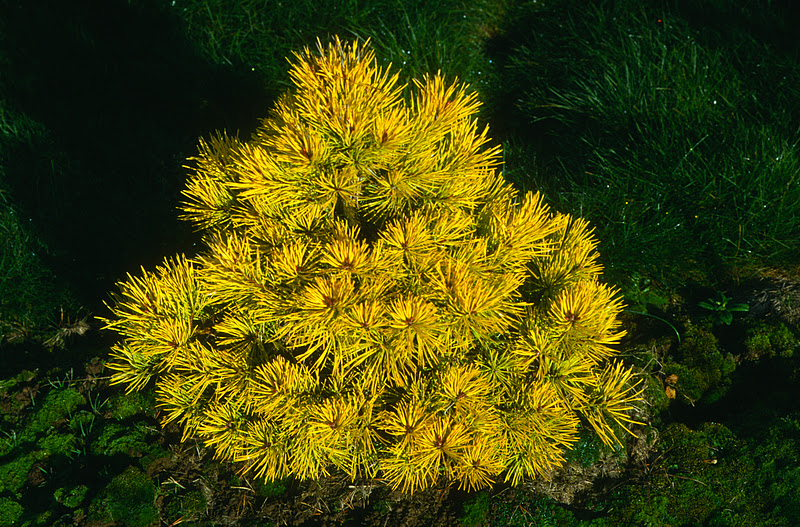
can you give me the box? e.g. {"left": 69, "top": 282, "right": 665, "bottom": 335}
{"left": 104, "top": 467, "right": 159, "bottom": 527}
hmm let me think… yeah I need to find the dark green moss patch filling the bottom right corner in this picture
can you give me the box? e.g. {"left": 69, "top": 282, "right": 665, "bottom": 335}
{"left": 592, "top": 415, "right": 800, "bottom": 527}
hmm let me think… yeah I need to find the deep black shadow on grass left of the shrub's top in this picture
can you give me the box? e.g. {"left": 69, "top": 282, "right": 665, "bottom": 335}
{"left": 0, "top": 0, "right": 270, "bottom": 305}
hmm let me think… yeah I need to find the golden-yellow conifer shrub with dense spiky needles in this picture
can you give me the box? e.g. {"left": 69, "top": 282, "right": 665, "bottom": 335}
{"left": 101, "top": 39, "right": 638, "bottom": 492}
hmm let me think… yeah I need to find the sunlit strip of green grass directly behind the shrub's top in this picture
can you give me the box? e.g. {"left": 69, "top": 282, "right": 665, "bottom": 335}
{"left": 175, "top": 0, "right": 508, "bottom": 90}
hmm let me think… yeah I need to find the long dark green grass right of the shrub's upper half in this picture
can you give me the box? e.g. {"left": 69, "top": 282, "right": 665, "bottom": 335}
{"left": 496, "top": 1, "right": 800, "bottom": 283}
